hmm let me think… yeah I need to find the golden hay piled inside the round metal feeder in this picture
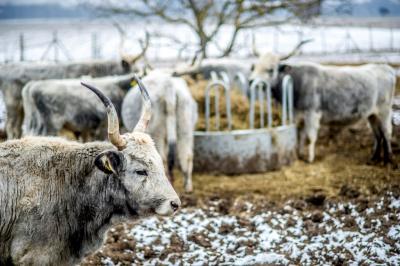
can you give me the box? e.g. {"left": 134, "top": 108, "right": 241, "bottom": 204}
{"left": 185, "top": 77, "right": 282, "bottom": 131}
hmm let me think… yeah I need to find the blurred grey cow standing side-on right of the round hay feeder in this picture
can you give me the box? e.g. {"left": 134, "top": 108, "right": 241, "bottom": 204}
{"left": 252, "top": 58, "right": 396, "bottom": 163}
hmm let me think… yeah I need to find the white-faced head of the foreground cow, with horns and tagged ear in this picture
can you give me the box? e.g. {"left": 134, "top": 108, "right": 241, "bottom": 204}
{"left": 82, "top": 77, "right": 181, "bottom": 215}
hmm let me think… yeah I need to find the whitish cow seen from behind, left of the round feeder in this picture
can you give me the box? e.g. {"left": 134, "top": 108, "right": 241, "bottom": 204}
{"left": 122, "top": 70, "right": 197, "bottom": 192}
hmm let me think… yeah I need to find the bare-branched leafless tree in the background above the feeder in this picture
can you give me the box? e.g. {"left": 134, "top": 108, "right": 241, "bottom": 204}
{"left": 95, "top": 0, "right": 321, "bottom": 58}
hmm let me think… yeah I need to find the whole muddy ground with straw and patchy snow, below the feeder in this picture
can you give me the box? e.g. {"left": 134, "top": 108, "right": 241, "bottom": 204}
{"left": 82, "top": 119, "right": 400, "bottom": 265}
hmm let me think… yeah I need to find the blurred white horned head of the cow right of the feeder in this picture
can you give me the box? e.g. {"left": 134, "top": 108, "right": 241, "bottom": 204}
{"left": 250, "top": 39, "right": 312, "bottom": 87}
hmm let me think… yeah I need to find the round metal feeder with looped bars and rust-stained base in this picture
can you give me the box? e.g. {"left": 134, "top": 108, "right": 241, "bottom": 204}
{"left": 194, "top": 72, "right": 297, "bottom": 174}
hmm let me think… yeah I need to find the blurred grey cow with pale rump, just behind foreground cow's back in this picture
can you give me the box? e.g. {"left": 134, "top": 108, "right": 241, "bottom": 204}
{"left": 22, "top": 74, "right": 134, "bottom": 141}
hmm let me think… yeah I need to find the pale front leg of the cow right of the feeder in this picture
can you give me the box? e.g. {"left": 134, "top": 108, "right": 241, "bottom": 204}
{"left": 304, "top": 111, "right": 322, "bottom": 163}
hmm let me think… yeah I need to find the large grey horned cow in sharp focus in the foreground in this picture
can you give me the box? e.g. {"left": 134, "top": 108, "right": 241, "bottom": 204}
{"left": 0, "top": 76, "right": 181, "bottom": 265}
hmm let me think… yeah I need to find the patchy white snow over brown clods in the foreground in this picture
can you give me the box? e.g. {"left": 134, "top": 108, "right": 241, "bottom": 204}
{"left": 90, "top": 194, "right": 400, "bottom": 266}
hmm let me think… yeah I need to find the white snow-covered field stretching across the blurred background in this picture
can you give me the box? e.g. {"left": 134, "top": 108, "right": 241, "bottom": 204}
{"left": 0, "top": 20, "right": 400, "bottom": 62}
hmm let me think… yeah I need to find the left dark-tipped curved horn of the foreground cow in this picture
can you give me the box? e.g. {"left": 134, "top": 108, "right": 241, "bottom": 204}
{"left": 81, "top": 82, "right": 126, "bottom": 150}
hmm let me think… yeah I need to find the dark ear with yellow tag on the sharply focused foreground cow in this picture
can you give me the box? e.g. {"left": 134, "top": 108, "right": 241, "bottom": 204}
{"left": 94, "top": 151, "right": 124, "bottom": 175}
